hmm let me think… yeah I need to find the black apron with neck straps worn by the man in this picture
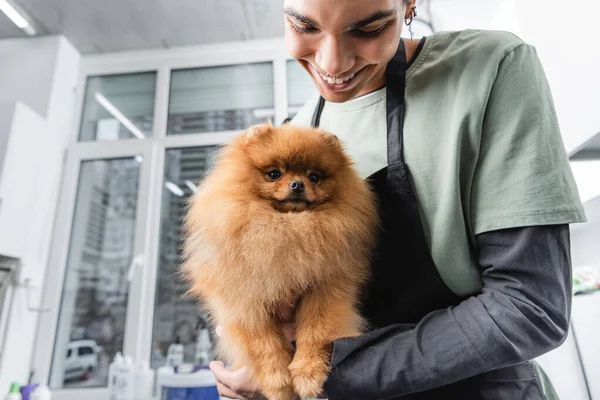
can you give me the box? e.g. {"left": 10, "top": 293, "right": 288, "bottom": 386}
{"left": 312, "top": 42, "right": 544, "bottom": 400}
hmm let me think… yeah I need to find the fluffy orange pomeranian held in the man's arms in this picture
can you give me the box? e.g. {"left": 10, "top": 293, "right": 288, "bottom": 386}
{"left": 183, "top": 125, "right": 378, "bottom": 400}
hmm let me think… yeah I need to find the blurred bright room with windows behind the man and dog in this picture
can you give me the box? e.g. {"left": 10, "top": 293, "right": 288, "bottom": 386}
{"left": 0, "top": 0, "right": 600, "bottom": 400}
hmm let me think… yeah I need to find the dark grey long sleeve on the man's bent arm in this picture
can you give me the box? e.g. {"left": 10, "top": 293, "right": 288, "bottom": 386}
{"left": 325, "top": 225, "right": 572, "bottom": 400}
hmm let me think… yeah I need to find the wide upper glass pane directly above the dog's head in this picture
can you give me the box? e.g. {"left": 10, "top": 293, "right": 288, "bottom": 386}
{"left": 167, "top": 63, "right": 275, "bottom": 135}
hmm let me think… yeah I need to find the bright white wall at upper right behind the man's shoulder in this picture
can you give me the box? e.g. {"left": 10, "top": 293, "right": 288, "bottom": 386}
{"left": 491, "top": 0, "right": 600, "bottom": 153}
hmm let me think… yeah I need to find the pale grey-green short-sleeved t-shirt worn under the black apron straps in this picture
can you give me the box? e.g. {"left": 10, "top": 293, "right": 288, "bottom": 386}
{"left": 292, "top": 30, "right": 585, "bottom": 296}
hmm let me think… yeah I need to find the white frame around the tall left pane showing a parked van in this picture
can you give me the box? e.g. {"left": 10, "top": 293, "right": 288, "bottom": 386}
{"left": 33, "top": 140, "right": 154, "bottom": 398}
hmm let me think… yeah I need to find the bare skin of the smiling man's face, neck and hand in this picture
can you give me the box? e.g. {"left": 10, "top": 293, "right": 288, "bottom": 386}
{"left": 210, "top": 0, "right": 419, "bottom": 400}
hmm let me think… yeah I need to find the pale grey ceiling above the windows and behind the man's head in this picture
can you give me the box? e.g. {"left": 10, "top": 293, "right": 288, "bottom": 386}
{"left": 0, "top": 0, "right": 501, "bottom": 54}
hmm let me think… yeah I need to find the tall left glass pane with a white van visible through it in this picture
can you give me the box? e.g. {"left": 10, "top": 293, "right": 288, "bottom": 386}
{"left": 50, "top": 157, "right": 141, "bottom": 389}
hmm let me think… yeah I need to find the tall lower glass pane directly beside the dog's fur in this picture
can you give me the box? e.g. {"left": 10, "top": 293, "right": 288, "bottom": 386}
{"left": 151, "top": 147, "right": 217, "bottom": 368}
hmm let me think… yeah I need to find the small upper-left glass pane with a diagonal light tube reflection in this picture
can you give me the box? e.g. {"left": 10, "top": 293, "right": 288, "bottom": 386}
{"left": 79, "top": 72, "right": 156, "bottom": 141}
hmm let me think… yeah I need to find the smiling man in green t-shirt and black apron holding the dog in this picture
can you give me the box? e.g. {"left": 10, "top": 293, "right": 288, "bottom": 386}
{"left": 212, "top": 0, "right": 585, "bottom": 400}
